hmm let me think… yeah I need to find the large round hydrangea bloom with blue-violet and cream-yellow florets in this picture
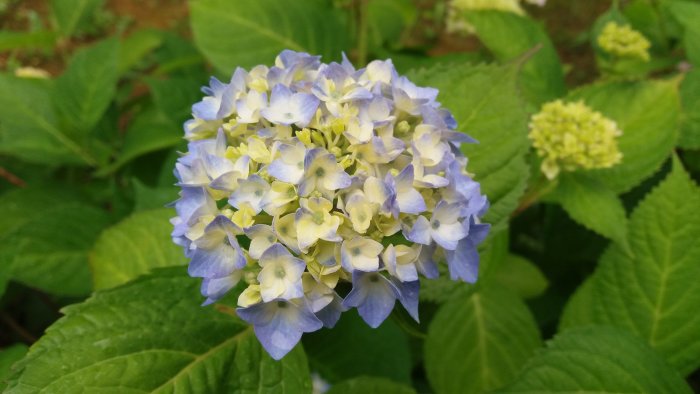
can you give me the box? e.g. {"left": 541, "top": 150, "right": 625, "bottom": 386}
{"left": 172, "top": 51, "right": 488, "bottom": 359}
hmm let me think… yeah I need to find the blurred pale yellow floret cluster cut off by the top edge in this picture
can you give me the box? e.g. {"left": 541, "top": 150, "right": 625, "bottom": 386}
{"left": 445, "top": 0, "right": 547, "bottom": 34}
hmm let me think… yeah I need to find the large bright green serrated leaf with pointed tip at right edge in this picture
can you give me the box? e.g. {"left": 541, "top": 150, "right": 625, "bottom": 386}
{"left": 560, "top": 160, "right": 700, "bottom": 375}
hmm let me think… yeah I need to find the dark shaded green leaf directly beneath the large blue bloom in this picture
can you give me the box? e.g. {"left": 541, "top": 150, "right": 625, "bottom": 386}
{"left": 303, "top": 310, "right": 412, "bottom": 384}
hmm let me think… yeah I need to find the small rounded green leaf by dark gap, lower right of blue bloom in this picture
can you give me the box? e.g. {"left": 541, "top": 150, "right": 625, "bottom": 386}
{"left": 496, "top": 254, "right": 549, "bottom": 299}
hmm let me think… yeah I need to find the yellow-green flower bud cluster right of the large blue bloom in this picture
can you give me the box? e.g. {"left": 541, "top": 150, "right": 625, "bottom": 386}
{"left": 529, "top": 100, "right": 622, "bottom": 179}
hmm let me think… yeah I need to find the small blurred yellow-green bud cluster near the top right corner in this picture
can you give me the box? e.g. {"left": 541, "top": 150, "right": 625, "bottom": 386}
{"left": 598, "top": 21, "right": 651, "bottom": 62}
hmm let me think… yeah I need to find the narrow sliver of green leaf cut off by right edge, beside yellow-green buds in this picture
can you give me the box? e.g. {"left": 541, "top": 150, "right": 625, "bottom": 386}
{"left": 678, "top": 69, "right": 700, "bottom": 149}
